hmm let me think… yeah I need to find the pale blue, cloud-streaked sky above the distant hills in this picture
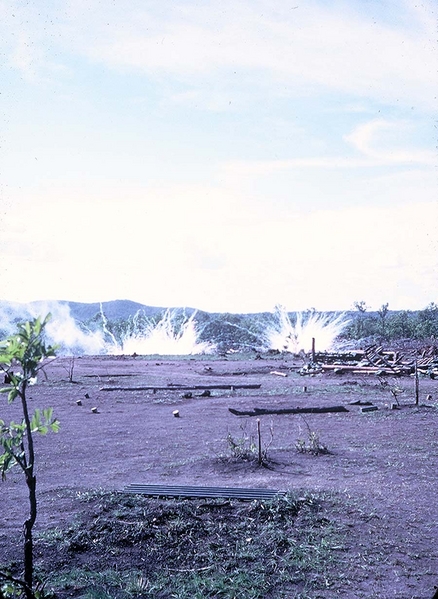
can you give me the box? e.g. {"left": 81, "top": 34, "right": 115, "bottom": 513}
{"left": 0, "top": 0, "right": 438, "bottom": 312}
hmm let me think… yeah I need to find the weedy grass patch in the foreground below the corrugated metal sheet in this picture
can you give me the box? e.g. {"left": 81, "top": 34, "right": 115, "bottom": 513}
{"left": 35, "top": 493, "right": 340, "bottom": 599}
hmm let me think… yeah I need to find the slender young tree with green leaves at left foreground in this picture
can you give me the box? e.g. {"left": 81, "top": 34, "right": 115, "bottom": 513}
{"left": 0, "top": 314, "right": 59, "bottom": 599}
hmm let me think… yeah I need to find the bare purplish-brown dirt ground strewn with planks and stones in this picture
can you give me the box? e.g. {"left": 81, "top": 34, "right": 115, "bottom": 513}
{"left": 0, "top": 355, "right": 438, "bottom": 599}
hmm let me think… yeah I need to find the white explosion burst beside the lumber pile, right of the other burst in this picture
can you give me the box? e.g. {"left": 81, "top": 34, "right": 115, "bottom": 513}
{"left": 265, "top": 306, "right": 349, "bottom": 353}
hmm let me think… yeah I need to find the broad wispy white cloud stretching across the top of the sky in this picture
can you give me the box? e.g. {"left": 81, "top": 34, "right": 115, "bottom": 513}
{"left": 53, "top": 0, "right": 438, "bottom": 110}
